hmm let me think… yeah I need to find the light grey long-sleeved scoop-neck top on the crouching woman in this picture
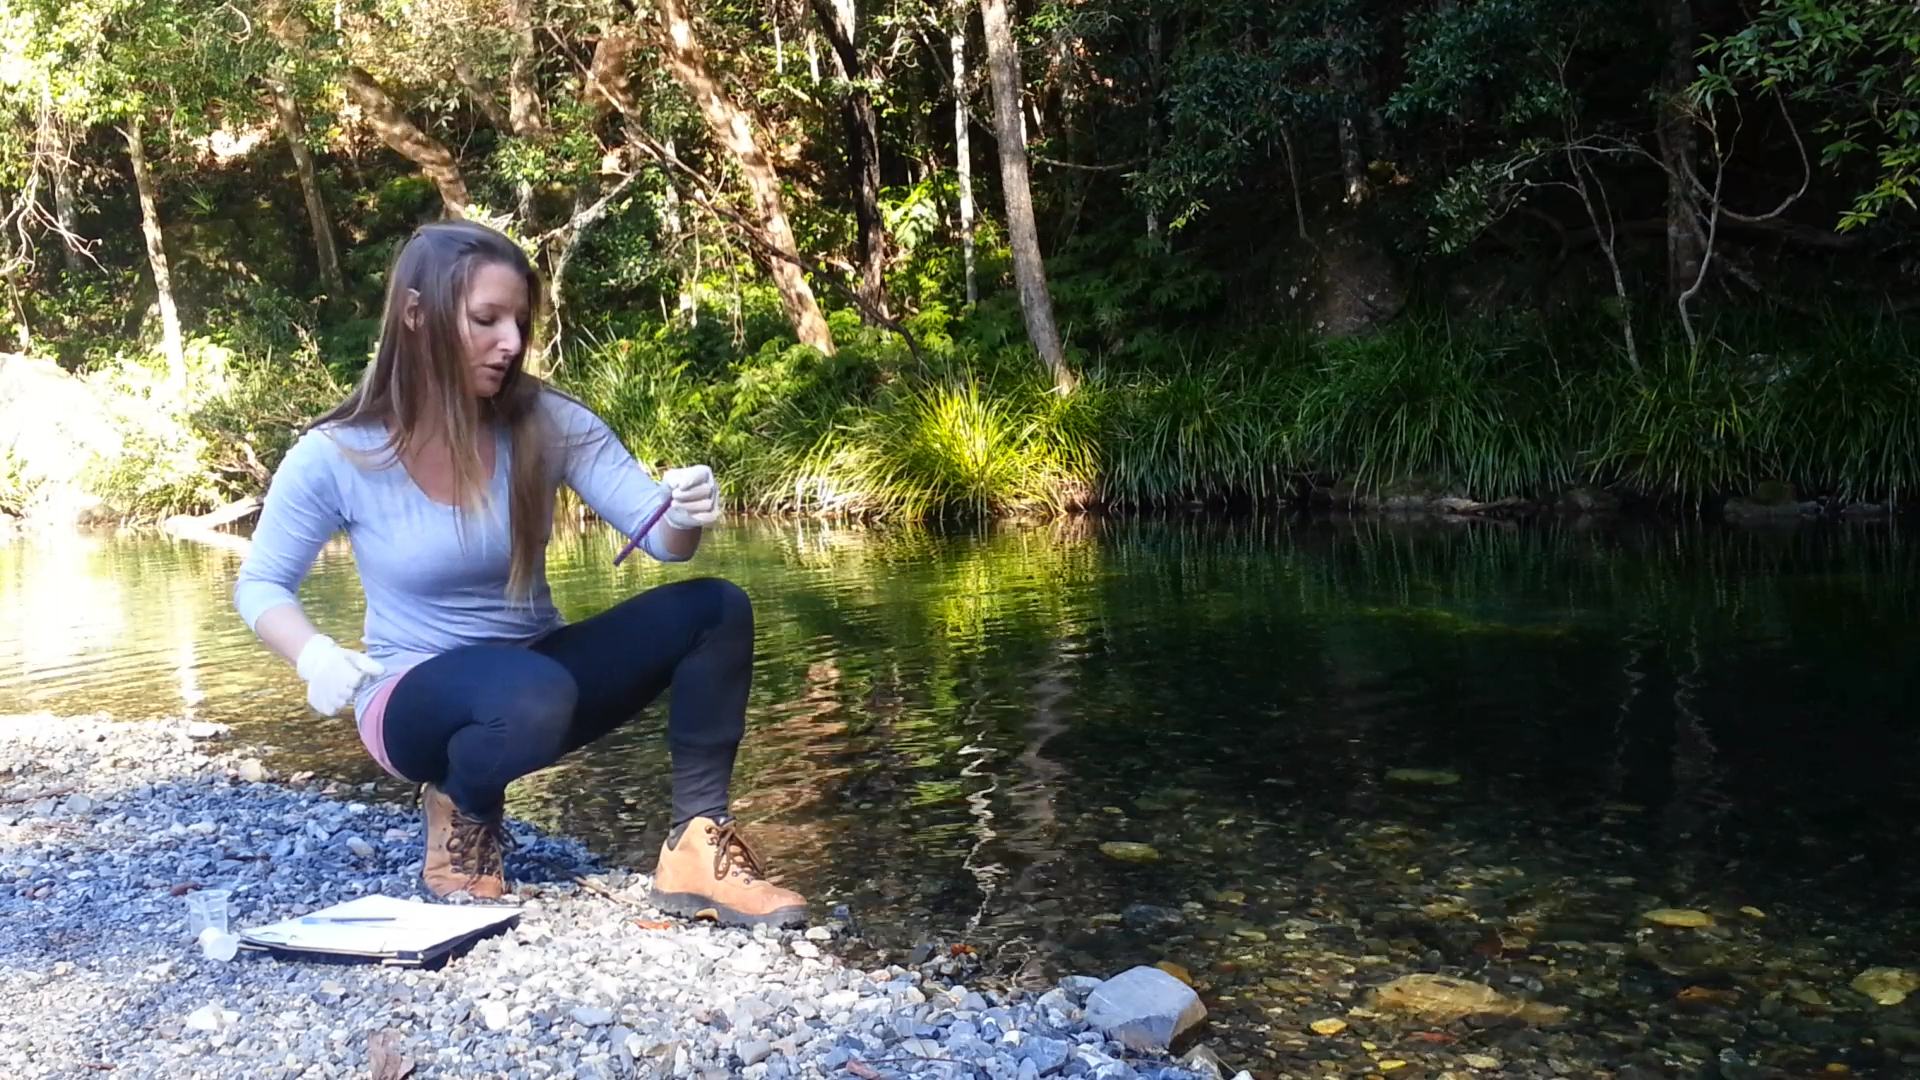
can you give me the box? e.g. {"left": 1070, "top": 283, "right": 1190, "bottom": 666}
{"left": 234, "top": 392, "right": 678, "bottom": 707}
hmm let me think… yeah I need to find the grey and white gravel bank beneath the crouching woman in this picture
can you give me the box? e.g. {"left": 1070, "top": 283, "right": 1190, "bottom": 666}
{"left": 0, "top": 715, "right": 1215, "bottom": 1080}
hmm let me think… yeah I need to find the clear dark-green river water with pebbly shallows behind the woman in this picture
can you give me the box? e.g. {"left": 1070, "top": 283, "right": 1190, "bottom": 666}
{"left": 11, "top": 519, "right": 1920, "bottom": 1076}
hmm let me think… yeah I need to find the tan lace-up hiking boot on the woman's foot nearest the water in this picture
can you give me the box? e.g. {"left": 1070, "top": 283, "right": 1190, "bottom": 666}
{"left": 653, "top": 817, "right": 806, "bottom": 926}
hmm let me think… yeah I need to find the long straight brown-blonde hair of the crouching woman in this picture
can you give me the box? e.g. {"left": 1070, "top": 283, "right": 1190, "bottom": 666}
{"left": 311, "top": 221, "right": 553, "bottom": 598}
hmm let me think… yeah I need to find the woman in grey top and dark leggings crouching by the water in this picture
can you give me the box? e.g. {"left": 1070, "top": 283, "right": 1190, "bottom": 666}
{"left": 234, "top": 221, "right": 806, "bottom": 926}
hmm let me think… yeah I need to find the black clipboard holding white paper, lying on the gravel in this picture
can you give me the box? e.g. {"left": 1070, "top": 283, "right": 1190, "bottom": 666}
{"left": 240, "top": 896, "right": 520, "bottom": 967}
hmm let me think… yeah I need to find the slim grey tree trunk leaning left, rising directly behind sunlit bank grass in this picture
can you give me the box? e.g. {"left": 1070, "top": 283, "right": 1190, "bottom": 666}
{"left": 979, "top": 0, "right": 1075, "bottom": 392}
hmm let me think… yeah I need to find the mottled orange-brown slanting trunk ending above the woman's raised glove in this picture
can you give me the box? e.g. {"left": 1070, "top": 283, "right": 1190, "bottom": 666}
{"left": 655, "top": 0, "right": 833, "bottom": 354}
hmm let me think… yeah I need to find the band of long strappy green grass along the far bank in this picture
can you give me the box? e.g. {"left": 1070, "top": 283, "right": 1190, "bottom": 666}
{"left": 566, "top": 307, "right": 1920, "bottom": 521}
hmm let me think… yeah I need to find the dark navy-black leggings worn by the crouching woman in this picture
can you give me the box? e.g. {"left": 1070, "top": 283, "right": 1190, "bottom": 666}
{"left": 386, "top": 578, "right": 753, "bottom": 828}
